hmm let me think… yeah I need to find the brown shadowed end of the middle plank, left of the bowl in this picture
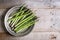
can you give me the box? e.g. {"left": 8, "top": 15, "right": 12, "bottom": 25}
{"left": 0, "top": 9, "right": 7, "bottom": 32}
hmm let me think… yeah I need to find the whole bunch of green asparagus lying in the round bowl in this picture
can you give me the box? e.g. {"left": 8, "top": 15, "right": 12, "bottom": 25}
{"left": 8, "top": 5, "right": 37, "bottom": 33}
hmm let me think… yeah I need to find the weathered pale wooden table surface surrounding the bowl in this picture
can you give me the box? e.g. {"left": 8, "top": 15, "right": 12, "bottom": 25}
{"left": 0, "top": 0, "right": 60, "bottom": 40}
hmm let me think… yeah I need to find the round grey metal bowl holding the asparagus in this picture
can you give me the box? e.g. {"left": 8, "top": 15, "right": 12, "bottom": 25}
{"left": 4, "top": 5, "right": 34, "bottom": 36}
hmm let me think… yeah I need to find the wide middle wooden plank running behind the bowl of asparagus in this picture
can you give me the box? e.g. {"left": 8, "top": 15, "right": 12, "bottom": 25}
{"left": 0, "top": 9, "right": 60, "bottom": 32}
